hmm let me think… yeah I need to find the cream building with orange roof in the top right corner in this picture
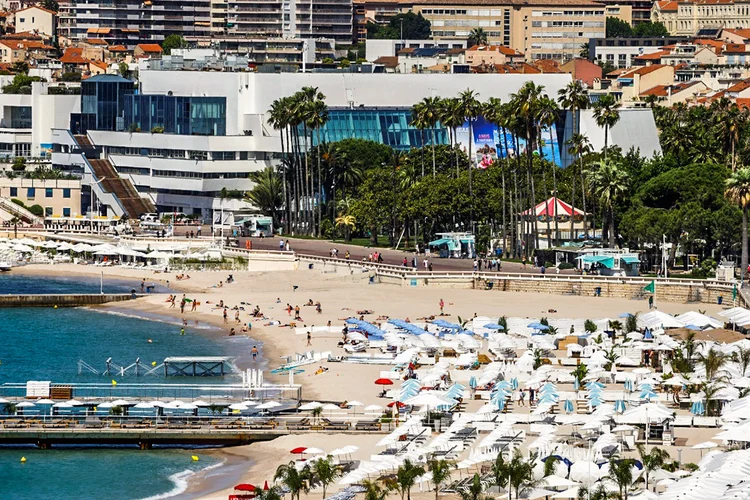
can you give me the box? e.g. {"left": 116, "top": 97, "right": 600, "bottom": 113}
{"left": 651, "top": 0, "right": 750, "bottom": 36}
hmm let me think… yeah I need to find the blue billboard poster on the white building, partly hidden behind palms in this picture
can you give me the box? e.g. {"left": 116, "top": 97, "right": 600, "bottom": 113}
{"left": 456, "top": 117, "right": 562, "bottom": 169}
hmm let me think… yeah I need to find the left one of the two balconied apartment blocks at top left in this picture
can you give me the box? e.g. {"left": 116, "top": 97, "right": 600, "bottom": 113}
{"left": 59, "top": 0, "right": 211, "bottom": 49}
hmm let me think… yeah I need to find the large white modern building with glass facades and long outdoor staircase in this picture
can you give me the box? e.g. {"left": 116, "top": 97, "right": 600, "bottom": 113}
{"left": 0, "top": 70, "right": 658, "bottom": 220}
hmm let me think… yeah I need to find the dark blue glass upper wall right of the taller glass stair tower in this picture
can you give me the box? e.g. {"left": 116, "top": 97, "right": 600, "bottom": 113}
{"left": 123, "top": 94, "right": 227, "bottom": 135}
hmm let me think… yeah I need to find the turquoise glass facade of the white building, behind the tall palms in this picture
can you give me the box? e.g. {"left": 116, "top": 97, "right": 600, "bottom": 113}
{"left": 312, "top": 108, "right": 448, "bottom": 151}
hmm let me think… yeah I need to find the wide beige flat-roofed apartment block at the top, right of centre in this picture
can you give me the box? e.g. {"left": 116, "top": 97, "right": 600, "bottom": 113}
{"left": 402, "top": 0, "right": 630, "bottom": 62}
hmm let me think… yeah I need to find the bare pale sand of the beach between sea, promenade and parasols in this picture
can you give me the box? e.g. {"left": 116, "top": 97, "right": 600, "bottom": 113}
{"left": 8, "top": 264, "right": 732, "bottom": 499}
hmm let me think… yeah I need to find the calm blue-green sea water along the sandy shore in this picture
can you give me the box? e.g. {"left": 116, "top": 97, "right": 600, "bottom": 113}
{"left": 0, "top": 274, "right": 250, "bottom": 500}
